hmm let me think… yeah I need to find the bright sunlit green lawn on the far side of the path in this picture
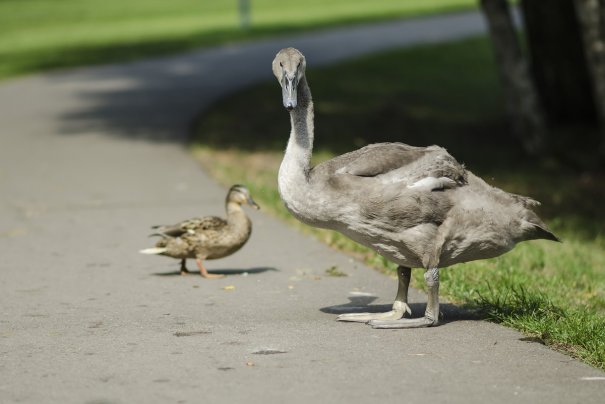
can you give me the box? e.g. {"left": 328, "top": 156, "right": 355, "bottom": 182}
{"left": 0, "top": 0, "right": 476, "bottom": 79}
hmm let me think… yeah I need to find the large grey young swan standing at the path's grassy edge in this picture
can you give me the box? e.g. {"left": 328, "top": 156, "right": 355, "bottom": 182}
{"left": 272, "top": 48, "right": 558, "bottom": 328}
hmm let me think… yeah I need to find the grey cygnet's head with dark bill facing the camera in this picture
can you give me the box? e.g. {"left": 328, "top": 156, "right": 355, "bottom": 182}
{"left": 273, "top": 48, "right": 307, "bottom": 111}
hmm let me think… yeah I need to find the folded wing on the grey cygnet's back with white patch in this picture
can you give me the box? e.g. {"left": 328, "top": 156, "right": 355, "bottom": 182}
{"left": 314, "top": 143, "right": 466, "bottom": 190}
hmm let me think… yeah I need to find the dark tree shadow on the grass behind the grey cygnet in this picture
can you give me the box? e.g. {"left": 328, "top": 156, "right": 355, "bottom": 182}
{"left": 194, "top": 39, "right": 605, "bottom": 239}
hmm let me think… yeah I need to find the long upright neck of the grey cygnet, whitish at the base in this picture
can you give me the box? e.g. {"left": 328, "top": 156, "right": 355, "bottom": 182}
{"left": 278, "top": 76, "right": 313, "bottom": 208}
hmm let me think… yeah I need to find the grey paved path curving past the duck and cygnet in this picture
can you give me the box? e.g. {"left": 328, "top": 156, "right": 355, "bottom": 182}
{"left": 0, "top": 13, "right": 605, "bottom": 403}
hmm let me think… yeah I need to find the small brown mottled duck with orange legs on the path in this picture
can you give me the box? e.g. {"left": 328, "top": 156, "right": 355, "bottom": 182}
{"left": 140, "top": 185, "right": 259, "bottom": 278}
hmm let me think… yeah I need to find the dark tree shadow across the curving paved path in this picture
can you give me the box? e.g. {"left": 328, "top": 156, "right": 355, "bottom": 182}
{"left": 37, "top": 11, "right": 485, "bottom": 143}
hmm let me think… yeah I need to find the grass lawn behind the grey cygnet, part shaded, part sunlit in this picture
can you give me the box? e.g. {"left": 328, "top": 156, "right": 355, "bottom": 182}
{"left": 193, "top": 38, "right": 605, "bottom": 369}
